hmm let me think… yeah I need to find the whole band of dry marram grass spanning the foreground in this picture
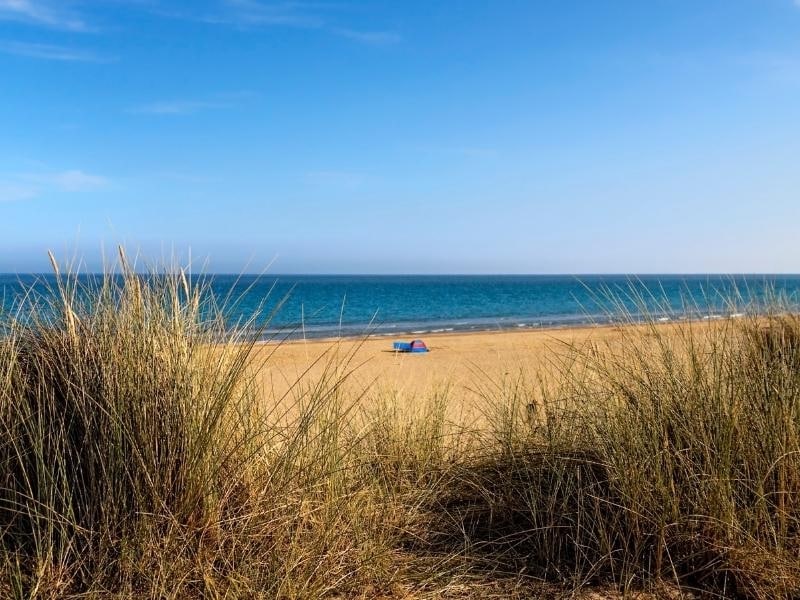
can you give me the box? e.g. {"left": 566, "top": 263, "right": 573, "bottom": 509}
{"left": 0, "top": 258, "right": 800, "bottom": 598}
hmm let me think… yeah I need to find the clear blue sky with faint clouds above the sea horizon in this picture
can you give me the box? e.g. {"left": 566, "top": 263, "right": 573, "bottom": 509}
{"left": 0, "top": 0, "right": 800, "bottom": 273}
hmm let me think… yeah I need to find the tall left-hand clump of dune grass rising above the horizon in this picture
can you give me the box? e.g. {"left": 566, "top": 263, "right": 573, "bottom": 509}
{"left": 0, "top": 251, "right": 440, "bottom": 598}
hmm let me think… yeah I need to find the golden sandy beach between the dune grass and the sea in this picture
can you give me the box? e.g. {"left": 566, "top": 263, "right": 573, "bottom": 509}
{"left": 254, "top": 320, "right": 728, "bottom": 427}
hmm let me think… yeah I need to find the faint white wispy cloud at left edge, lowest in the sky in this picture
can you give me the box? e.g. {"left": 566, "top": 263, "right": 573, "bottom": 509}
{"left": 0, "top": 169, "right": 111, "bottom": 202}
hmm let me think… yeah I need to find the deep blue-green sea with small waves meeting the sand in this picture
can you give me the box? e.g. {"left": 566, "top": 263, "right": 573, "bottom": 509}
{"left": 0, "top": 275, "right": 800, "bottom": 338}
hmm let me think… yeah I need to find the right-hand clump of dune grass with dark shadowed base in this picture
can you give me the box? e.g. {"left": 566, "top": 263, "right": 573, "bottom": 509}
{"left": 424, "top": 300, "right": 800, "bottom": 598}
